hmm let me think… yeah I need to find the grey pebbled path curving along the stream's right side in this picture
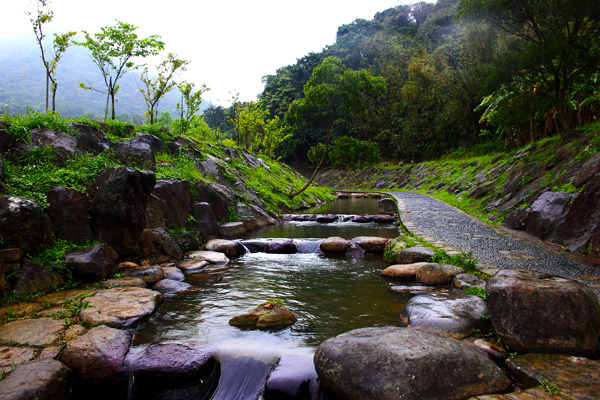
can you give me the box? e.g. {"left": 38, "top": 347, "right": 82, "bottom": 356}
{"left": 389, "top": 192, "right": 600, "bottom": 297}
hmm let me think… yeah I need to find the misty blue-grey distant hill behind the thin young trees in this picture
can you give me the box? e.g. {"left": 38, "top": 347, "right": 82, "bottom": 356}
{"left": 0, "top": 32, "right": 210, "bottom": 120}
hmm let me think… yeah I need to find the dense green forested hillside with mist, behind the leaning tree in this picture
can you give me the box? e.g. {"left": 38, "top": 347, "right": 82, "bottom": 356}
{"left": 260, "top": 0, "right": 600, "bottom": 162}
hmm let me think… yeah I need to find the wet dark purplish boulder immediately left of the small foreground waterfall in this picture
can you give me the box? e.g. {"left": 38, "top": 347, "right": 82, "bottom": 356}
{"left": 127, "top": 341, "right": 219, "bottom": 399}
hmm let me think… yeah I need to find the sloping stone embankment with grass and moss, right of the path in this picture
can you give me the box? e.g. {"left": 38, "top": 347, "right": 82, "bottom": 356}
{"left": 316, "top": 131, "right": 600, "bottom": 258}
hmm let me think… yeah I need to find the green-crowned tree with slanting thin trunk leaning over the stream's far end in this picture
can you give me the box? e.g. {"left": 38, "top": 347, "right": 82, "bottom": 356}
{"left": 285, "top": 57, "right": 386, "bottom": 197}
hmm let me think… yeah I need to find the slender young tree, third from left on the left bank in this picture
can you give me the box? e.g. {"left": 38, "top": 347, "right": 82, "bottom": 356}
{"left": 140, "top": 53, "right": 190, "bottom": 125}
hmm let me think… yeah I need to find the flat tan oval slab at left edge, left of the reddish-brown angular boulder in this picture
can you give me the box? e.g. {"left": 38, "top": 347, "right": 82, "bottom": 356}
{"left": 0, "top": 318, "right": 65, "bottom": 346}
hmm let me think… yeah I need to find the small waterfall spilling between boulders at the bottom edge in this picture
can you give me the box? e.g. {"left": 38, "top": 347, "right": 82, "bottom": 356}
{"left": 211, "top": 342, "right": 279, "bottom": 400}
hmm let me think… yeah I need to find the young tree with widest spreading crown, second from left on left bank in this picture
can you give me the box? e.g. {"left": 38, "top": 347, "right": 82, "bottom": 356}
{"left": 78, "top": 20, "right": 165, "bottom": 119}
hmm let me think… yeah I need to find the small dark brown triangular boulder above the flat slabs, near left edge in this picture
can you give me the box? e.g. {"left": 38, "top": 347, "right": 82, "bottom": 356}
{"left": 14, "top": 258, "right": 66, "bottom": 296}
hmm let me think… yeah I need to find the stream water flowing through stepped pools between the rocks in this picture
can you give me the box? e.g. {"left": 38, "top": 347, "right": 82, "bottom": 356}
{"left": 125, "top": 199, "right": 410, "bottom": 399}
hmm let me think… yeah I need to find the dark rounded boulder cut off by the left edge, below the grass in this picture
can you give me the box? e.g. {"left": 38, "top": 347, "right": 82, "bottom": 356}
{"left": 0, "top": 196, "right": 54, "bottom": 256}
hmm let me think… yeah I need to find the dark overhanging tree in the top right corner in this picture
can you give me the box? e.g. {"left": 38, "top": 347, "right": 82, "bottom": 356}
{"left": 461, "top": 0, "right": 600, "bottom": 131}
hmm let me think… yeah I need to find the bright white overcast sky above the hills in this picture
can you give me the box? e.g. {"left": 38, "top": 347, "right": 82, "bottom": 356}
{"left": 0, "top": 0, "right": 414, "bottom": 105}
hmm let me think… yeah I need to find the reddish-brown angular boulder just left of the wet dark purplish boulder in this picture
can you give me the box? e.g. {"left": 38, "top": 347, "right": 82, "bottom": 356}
{"left": 60, "top": 325, "right": 132, "bottom": 390}
